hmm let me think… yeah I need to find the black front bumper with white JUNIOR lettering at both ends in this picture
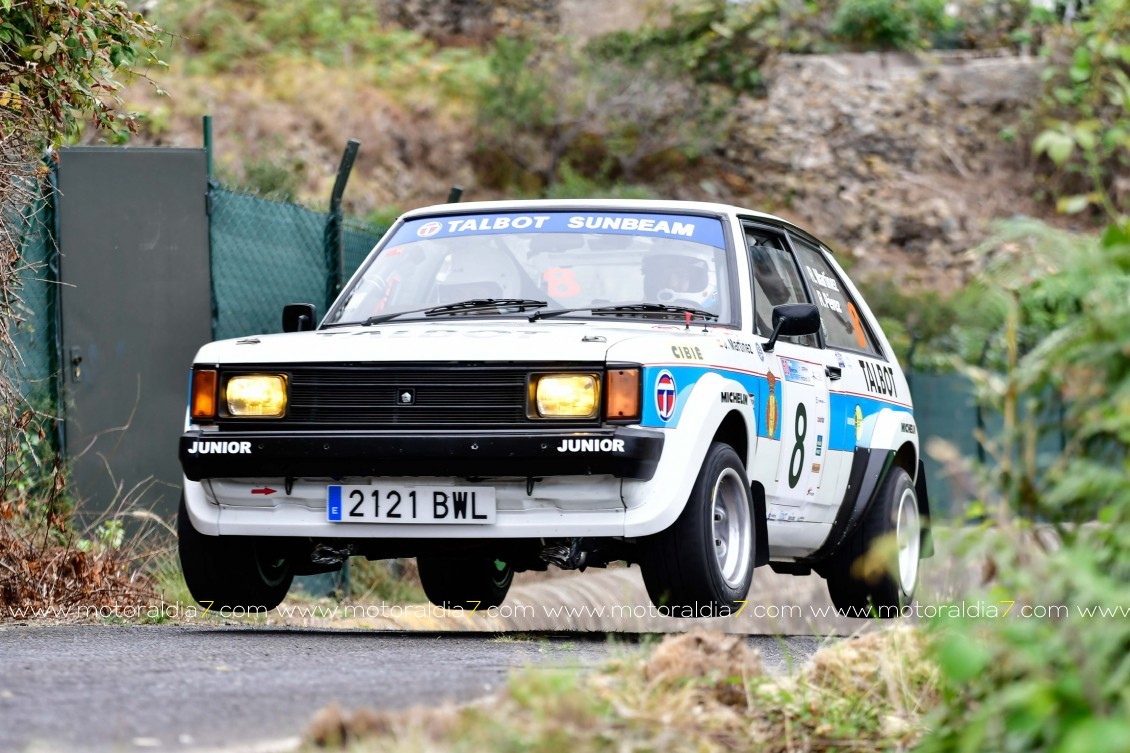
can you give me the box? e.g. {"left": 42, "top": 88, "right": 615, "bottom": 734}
{"left": 180, "top": 427, "right": 663, "bottom": 481}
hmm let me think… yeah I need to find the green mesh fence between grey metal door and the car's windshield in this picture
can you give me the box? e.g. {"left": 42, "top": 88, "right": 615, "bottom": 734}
{"left": 210, "top": 187, "right": 383, "bottom": 339}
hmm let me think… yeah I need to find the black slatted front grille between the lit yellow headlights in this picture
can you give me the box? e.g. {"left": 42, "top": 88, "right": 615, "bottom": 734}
{"left": 213, "top": 364, "right": 599, "bottom": 430}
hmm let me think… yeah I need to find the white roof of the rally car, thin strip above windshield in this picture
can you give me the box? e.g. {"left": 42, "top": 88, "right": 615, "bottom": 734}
{"left": 401, "top": 199, "right": 831, "bottom": 251}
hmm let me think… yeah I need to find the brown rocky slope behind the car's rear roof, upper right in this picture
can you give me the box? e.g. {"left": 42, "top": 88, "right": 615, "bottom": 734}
{"left": 722, "top": 53, "right": 1044, "bottom": 282}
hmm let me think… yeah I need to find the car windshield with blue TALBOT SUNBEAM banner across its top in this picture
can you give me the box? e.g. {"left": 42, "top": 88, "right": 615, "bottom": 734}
{"left": 327, "top": 211, "right": 736, "bottom": 324}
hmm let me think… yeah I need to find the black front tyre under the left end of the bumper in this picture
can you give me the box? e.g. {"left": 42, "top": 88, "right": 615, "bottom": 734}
{"left": 176, "top": 494, "right": 294, "bottom": 612}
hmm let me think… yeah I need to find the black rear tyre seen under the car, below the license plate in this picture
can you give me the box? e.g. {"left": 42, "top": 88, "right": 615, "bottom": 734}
{"left": 416, "top": 555, "right": 514, "bottom": 611}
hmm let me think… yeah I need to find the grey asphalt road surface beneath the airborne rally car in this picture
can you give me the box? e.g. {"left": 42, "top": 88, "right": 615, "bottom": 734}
{"left": 0, "top": 625, "right": 819, "bottom": 753}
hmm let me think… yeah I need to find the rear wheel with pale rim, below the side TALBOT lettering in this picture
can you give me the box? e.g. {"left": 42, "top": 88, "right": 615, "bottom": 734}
{"left": 826, "top": 467, "right": 922, "bottom": 618}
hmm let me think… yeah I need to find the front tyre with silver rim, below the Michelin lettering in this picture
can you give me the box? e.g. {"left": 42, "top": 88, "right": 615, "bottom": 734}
{"left": 641, "top": 442, "right": 756, "bottom": 614}
